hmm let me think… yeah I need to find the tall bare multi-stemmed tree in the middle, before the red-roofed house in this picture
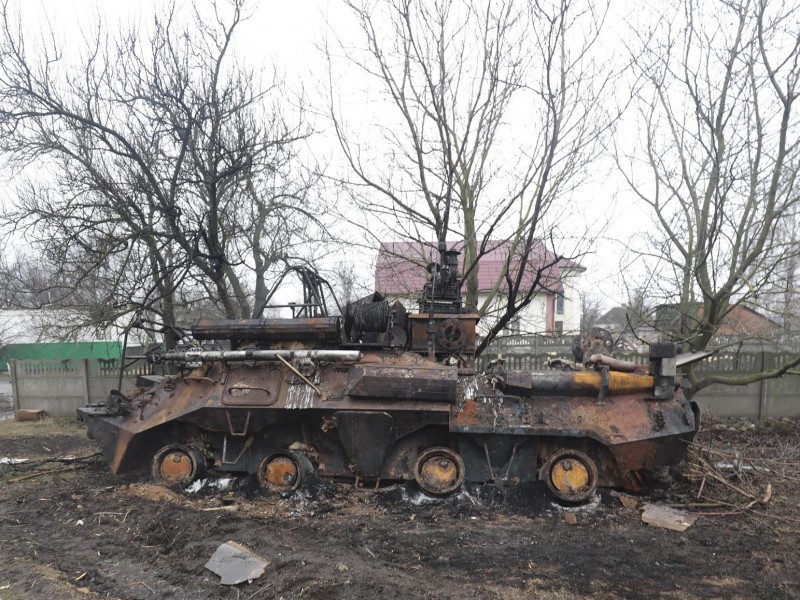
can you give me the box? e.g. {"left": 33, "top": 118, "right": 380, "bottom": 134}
{"left": 326, "top": 0, "right": 611, "bottom": 352}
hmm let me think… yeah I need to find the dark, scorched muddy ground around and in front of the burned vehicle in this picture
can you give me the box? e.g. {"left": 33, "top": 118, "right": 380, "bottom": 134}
{"left": 0, "top": 421, "right": 800, "bottom": 600}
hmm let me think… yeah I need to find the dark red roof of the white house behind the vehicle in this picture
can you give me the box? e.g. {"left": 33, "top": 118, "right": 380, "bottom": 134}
{"left": 375, "top": 241, "right": 584, "bottom": 295}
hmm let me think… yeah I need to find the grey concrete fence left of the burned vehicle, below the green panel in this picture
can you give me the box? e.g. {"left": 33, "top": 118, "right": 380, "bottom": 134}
{"left": 9, "top": 359, "right": 149, "bottom": 416}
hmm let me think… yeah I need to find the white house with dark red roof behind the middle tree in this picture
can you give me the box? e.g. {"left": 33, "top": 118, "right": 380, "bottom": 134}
{"left": 375, "top": 240, "right": 586, "bottom": 335}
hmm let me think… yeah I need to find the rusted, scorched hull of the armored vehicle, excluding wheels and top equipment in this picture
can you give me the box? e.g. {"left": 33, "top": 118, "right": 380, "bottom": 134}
{"left": 80, "top": 355, "right": 696, "bottom": 489}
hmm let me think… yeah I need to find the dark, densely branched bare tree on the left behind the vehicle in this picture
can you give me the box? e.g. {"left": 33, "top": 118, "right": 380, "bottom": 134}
{"left": 0, "top": 0, "right": 316, "bottom": 342}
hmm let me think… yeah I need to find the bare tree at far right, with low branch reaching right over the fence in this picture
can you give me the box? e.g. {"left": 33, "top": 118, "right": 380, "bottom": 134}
{"left": 617, "top": 0, "right": 800, "bottom": 391}
